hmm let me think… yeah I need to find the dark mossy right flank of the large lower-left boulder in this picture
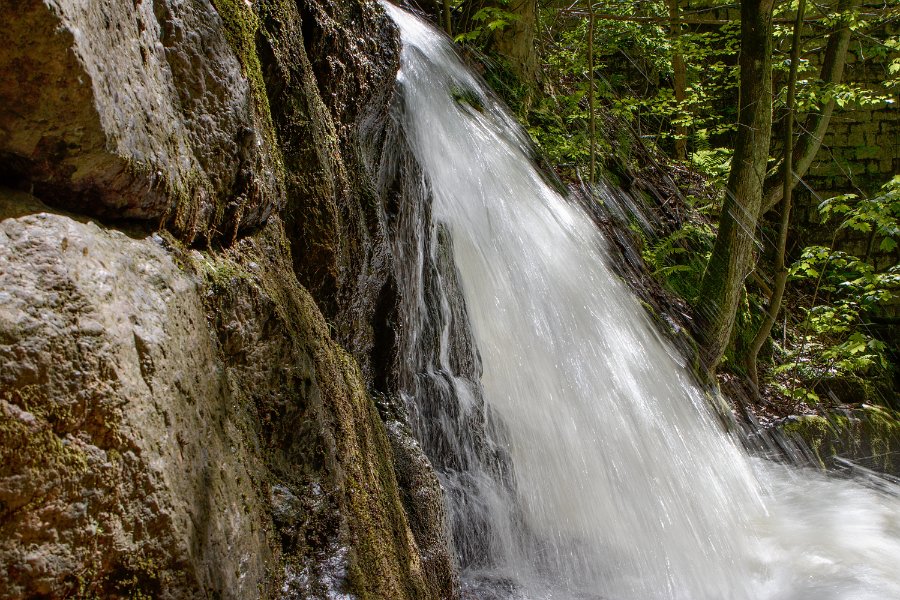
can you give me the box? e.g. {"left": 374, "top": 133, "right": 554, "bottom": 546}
{"left": 199, "top": 220, "right": 438, "bottom": 598}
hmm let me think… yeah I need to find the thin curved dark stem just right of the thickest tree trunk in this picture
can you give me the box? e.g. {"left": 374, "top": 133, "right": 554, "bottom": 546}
{"left": 745, "top": 0, "right": 806, "bottom": 392}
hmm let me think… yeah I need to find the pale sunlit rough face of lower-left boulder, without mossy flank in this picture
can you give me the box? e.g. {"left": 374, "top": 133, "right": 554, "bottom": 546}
{"left": 0, "top": 197, "right": 273, "bottom": 598}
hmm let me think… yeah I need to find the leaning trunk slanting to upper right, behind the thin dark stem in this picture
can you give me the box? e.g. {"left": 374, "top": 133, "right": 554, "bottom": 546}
{"left": 763, "top": 0, "right": 860, "bottom": 213}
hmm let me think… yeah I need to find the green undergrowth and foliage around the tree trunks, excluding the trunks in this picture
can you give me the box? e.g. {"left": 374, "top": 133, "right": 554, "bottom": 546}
{"left": 444, "top": 1, "right": 900, "bottom": 434}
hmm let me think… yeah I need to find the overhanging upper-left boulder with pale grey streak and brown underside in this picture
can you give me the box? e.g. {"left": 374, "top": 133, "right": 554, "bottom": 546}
{"left": 0, "top": 0, "right": 281, "bottom": 241}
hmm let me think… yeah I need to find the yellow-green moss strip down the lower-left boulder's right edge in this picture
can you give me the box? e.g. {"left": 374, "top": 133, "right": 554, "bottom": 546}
{"left": 193, "top": 221, "right": 429, "bottom": 600}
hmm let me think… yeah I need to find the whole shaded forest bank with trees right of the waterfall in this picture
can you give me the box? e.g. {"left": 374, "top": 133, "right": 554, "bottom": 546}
{"left": 410, "top": 0, "right": 900, "bottom": 418}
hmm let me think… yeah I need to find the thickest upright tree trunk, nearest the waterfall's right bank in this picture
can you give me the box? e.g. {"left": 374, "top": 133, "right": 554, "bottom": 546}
{"left": 697, "top": 0, "right": 774, "bottom": 376}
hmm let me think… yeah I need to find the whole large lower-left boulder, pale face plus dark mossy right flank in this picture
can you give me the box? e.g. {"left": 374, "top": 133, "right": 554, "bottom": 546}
{"left": 0, "top": 196, "right": 440, "bottom": 598}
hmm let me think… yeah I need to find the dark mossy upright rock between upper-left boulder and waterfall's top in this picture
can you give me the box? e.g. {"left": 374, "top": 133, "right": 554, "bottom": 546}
{"left": 257, "top": 0, "right": 400, "bottom": 378}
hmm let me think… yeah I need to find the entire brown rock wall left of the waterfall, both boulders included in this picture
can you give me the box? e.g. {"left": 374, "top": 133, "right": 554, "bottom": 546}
{"left": 0, "top": 0, "right": 456, "bottom": 598}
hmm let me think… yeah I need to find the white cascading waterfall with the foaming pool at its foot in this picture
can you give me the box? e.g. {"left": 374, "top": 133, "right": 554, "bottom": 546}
{"left": 384, "top": 4, "right": 900, "bottom": 600}
